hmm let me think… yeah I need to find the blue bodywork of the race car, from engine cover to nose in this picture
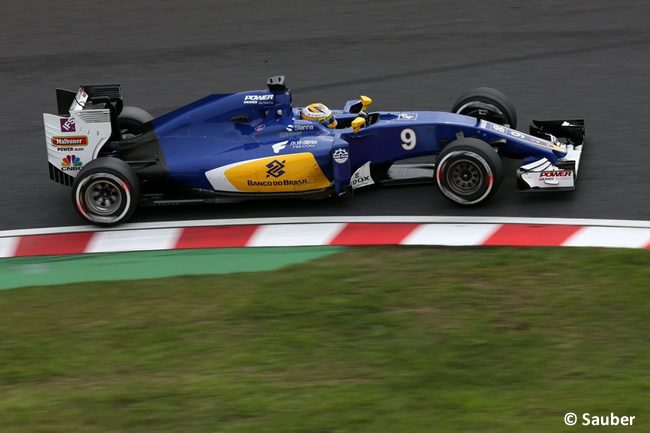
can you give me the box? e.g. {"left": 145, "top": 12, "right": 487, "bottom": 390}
{"left": 146, "top": 82, "right": 566, "bottom": 193}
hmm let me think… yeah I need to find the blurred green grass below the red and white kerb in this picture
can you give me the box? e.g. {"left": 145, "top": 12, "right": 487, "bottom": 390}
{"left": 0, "top": 247, "right": 650, "bottom": 433}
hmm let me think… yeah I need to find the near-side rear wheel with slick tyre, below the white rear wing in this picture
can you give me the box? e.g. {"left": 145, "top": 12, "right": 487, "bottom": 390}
{"left": 72, "top": 157, "right": 140, "bottom": 226}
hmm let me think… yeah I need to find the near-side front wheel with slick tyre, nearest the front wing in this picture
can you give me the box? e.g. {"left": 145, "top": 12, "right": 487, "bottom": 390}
{"left": 436, "top": 138, "right": 503, "bottom": 205}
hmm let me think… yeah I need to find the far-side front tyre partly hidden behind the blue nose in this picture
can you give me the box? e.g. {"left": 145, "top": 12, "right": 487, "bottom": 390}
{"left": 451, "top": 87, "right": 517, "bottom": 129}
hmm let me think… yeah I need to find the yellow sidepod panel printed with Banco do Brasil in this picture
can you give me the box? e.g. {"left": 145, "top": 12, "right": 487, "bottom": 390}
{"left": 224, "top": 152, "right": 330, "bottom": 192}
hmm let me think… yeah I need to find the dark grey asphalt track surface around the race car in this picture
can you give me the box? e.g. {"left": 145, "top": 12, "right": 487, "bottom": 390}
{"left": 0, "top": 0, "right": 650, "bottom": 230}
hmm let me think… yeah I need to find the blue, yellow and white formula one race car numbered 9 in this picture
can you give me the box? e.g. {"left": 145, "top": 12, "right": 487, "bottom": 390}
{"left": 43, "top": 76, "right": 584, "bottom": 225}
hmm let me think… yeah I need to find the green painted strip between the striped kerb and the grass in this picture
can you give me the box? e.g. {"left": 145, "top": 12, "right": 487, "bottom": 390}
{"left": 0, "top": 246, "right": 344, "bottom": 289}
